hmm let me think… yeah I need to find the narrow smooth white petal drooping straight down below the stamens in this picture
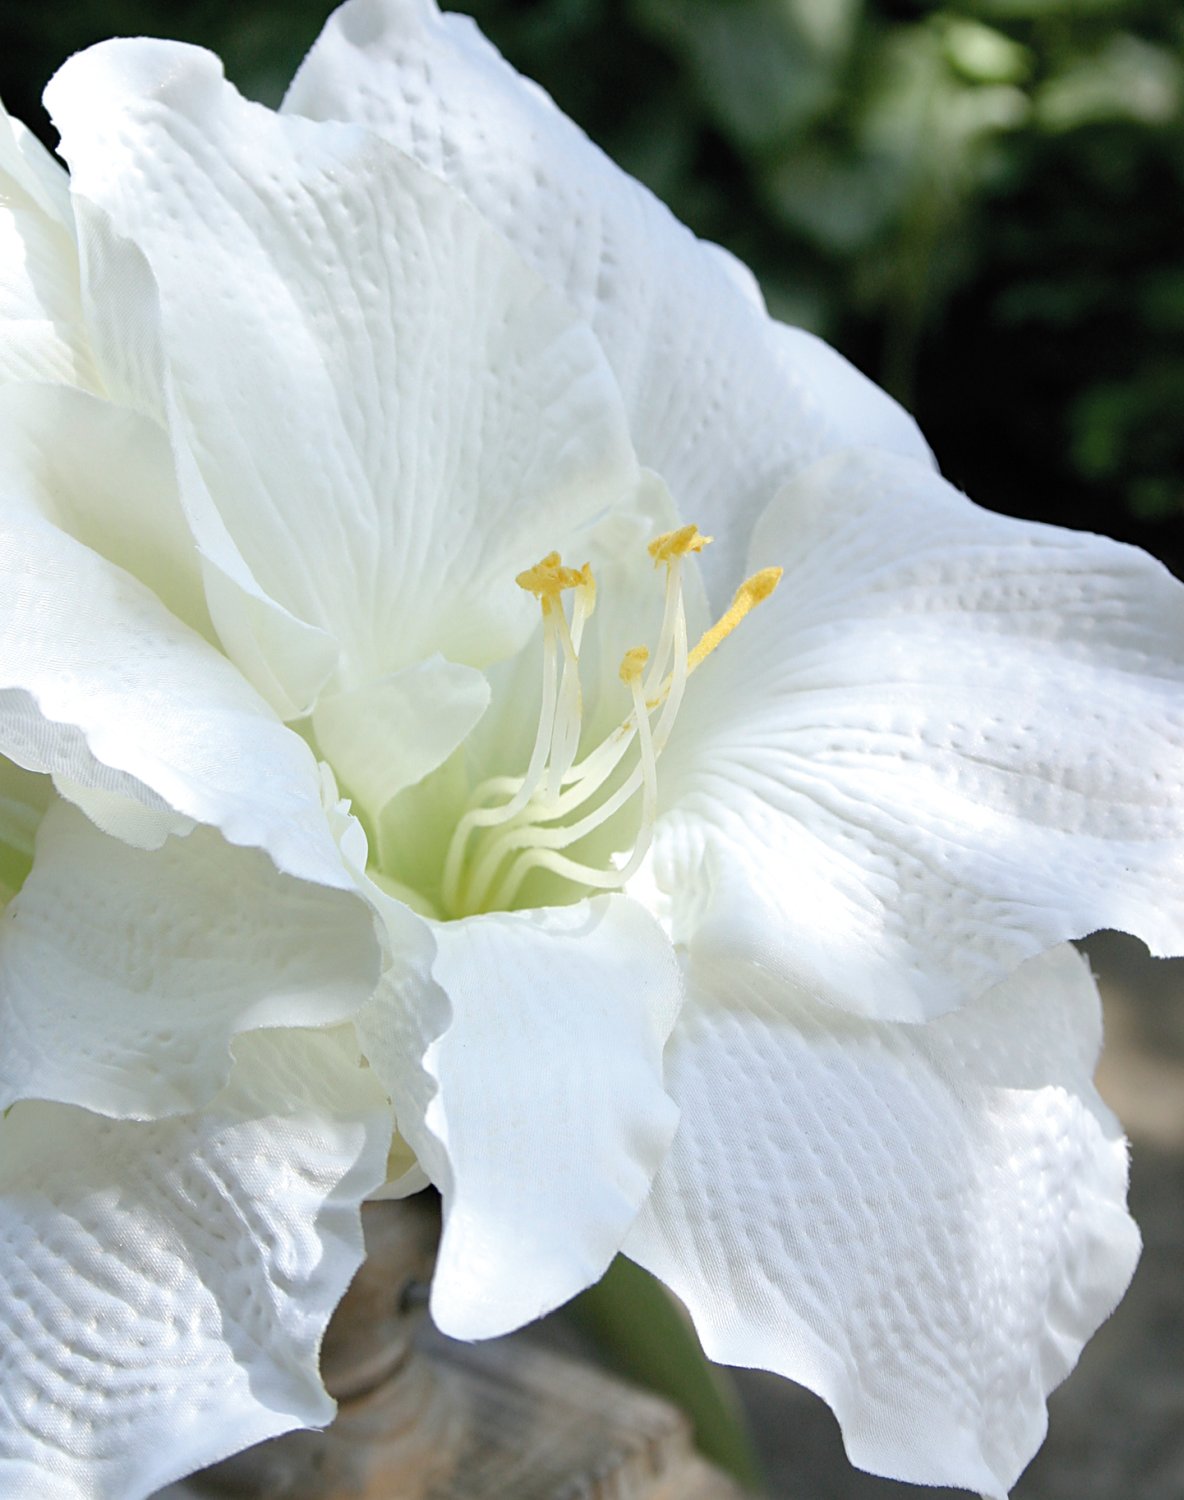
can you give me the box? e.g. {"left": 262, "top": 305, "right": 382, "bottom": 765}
{"left": 360, "top": 896, "right": 681, "bottom": 1338}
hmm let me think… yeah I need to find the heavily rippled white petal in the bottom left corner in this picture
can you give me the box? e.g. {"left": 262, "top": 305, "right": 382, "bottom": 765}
{"left": 0, "top": 1032, "right": 390, "bottom": 1500}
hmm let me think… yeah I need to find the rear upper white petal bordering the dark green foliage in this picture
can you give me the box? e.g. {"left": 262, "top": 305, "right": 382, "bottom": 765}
{"left": 284, "top": 0, "right": 929, "bottom": 594}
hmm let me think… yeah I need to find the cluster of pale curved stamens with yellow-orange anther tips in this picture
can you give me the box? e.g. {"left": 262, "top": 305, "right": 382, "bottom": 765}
{"left": 441, "top": 525, "right": 782, "bottom": 917}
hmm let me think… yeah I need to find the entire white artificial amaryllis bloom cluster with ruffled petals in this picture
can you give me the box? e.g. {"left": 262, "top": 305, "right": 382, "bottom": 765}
{"left": 0, "top": 0, "right": 1184, "bottom": 1500}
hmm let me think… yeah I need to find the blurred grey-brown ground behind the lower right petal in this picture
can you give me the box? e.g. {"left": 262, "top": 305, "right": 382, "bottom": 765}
{"left": 738, "top": 933, "right": 1184, "bottom": 1500}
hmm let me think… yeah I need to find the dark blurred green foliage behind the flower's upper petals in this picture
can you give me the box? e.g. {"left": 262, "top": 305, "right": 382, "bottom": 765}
{"left": 0, "top": 0, "right": 1184, "bottom": 569}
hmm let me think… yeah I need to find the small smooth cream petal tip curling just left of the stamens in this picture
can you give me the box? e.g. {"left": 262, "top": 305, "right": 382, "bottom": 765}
{"left": 312, "top": 656, "right": 489, "bottom": 818}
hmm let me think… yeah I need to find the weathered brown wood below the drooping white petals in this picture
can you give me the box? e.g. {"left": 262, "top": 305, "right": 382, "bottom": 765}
{"left": 159, "top": 1200, "right": 741, "bottom": 1500}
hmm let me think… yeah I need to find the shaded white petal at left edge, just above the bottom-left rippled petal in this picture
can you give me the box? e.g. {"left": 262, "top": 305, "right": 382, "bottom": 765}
{"left": 0, "top": 803, "right": 380, "bottom": 1119}
